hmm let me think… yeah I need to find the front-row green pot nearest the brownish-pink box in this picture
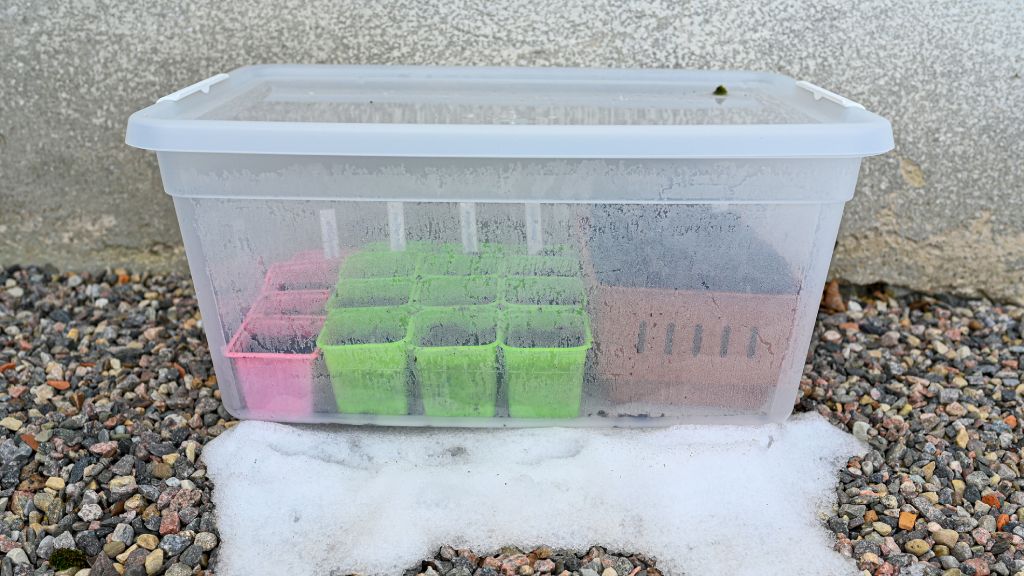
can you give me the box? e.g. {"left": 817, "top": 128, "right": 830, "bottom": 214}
{"left": 502, "top": 306, "right": 593, "bottom": 418}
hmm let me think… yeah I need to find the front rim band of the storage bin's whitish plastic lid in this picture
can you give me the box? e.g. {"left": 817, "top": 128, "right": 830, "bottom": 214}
{"left": 125, "top": 113, "right": 894, "bottom": 159}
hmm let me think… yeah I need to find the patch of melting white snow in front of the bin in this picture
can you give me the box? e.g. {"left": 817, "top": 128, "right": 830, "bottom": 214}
{"left": 204, "top": 414, "right": 863, "bottom": 576}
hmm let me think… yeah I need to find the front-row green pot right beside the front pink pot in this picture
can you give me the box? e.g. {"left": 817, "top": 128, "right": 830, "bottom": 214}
{"left": 316, "top": 307, "right": 411, "bottom": 414}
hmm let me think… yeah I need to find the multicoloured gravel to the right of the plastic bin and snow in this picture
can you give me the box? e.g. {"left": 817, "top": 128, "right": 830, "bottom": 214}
{"left": 798, "top": 282, "right": 1024, "bottom": 576}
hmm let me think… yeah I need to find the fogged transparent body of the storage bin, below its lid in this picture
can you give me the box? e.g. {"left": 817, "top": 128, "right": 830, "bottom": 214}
{"left": 160, "top": 153, "right": 859, "bottom": 426}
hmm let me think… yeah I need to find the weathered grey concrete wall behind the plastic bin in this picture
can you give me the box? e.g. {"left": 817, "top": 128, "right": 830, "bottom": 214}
{"left": 0, "top": 0, "right": 1024, "bottom": 299}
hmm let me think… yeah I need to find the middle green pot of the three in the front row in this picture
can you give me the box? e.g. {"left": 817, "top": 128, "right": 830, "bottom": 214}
{"left": 412, "top": 306, "right": 500, "bottom": 417}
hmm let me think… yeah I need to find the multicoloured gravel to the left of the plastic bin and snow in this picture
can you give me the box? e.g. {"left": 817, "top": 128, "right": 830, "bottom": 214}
{"left": 0, "top": 266, "right": 230, "bottom": 576}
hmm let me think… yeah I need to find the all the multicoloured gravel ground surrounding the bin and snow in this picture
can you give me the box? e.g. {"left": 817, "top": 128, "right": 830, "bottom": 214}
{"left": 0, "top": 266, "right": 1024, "bottom": 576}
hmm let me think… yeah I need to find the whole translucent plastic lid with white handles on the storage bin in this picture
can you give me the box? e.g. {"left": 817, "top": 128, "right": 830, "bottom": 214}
{"left": 126, "top": 65, "right": 893, "bottom": 158}
